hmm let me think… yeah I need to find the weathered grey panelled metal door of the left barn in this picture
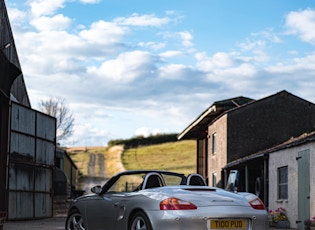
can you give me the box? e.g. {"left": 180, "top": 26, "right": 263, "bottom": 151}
{"left": 8, "top": 102, "right": 56, "bottom": 220}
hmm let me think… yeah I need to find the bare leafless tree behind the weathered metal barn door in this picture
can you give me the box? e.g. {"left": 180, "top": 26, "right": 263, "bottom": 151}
{"left": 39, "top": 97, "right": 74, "bottom": 143}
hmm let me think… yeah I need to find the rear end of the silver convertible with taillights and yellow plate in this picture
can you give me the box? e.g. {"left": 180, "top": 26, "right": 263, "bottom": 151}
{"left": 147, "top": 186, "right": 268, "bottom": 230}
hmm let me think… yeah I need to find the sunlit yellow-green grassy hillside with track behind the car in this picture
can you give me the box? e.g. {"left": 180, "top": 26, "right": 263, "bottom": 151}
{"left": 68, "top": 141, "right": 196, "bottom": 188}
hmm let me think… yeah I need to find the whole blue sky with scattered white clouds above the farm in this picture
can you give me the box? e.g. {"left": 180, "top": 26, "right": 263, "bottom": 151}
{"left": 6, "top": 0, "right": 315, "bottom": 146}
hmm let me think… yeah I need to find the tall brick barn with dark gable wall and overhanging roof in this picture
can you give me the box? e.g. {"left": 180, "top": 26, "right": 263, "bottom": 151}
{"left": 178, "top": 91, "right": 315, "bottom": 207}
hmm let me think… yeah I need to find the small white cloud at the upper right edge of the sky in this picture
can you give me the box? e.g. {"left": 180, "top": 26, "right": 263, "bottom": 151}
{"left": 285, "top": 9, "right": 315, "bottom": 45}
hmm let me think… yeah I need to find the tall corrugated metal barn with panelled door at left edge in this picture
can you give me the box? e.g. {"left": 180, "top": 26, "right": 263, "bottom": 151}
{"left": 0, "top": 0, "right": 56, "bottom": 220}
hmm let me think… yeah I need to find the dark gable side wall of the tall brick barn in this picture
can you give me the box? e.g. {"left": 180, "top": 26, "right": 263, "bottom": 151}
{"left": 227, "top": 91, "right": 315, "bottom": 162}
